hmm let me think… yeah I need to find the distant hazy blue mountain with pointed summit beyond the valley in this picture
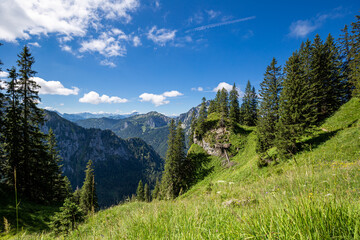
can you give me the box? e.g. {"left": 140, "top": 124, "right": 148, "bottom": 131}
{"left": 75, "top": 106, "right": 200, "bottom": 158}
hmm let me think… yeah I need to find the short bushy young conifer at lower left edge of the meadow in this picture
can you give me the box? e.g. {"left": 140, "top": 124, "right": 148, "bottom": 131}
{"left": 50, "top": 198, "right": 84, "bottom": 235}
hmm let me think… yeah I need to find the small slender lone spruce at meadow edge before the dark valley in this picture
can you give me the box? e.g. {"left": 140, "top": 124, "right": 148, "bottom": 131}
{"left": 80, "top": 160, "right": 98, "bottom": 215}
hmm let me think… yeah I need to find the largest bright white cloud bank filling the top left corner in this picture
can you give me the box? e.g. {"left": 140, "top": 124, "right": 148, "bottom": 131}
{"left": 0, "top": 0, "right": 140, "bottom": 42}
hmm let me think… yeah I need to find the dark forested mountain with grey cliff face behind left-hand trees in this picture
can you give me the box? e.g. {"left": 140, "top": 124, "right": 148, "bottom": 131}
{"left": 43, "top": 111, "right": 163, "bottom": 207}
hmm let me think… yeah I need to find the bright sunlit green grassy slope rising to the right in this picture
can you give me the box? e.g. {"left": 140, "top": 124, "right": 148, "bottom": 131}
{"left": 10, "top": 99, "right": 360, "bottom": 239}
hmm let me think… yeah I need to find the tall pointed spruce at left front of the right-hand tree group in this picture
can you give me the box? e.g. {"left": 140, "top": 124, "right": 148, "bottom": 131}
{"left": 257, "top": 58, "right": 282, "bottom": 153}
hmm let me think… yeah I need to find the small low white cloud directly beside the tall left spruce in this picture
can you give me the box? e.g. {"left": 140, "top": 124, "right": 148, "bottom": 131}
{"left": 33, "top": 77, "right": 79, "bottom": 96}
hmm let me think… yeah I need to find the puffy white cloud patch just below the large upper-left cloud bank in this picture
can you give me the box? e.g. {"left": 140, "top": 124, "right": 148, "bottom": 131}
{"left": 79, "top": 31, "right": 126, "bottom": 57}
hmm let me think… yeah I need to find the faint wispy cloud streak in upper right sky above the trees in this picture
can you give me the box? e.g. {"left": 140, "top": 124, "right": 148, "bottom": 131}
{"left": 288, "top": 8, "right": 344, "bottom": 38}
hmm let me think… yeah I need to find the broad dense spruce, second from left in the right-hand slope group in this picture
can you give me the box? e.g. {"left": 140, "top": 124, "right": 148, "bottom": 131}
{"left": 275, "top": 52, "right": 313, "bottom": 158}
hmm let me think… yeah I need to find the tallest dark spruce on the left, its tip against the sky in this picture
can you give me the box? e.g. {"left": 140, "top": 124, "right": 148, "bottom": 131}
{"left": 16, "top": 46, "right": 48, "bottom": 201}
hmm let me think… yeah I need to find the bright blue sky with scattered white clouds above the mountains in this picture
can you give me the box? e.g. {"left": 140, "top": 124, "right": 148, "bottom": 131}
{"left": 0, "top": 0, "right": 360, "bottom": 115}
